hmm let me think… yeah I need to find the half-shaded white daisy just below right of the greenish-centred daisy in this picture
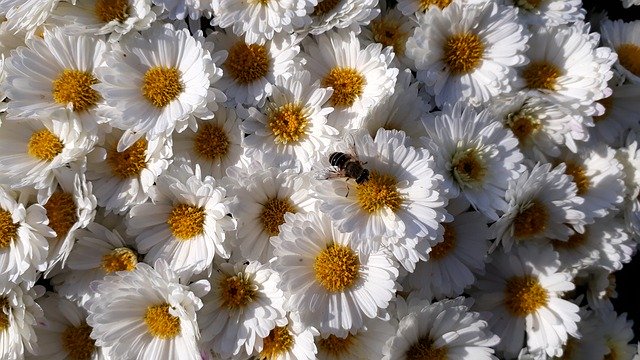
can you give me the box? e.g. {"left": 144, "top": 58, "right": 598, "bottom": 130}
{"left": 489, "top": 163, "right": 585, "bottom": 252}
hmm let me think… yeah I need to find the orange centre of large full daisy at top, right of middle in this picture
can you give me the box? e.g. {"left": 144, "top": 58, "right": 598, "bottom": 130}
{"left": 442, "top": 33, "right": 484, "bottom": 75}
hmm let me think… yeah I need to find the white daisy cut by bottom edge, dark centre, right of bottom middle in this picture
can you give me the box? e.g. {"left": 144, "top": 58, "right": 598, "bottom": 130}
{"left": 382, "top": 297, "right": 500, "bottom": 360}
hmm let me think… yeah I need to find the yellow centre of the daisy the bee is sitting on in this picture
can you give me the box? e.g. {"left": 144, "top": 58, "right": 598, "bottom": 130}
{"left": 357, "top": 171, "right": 404, "bottom": 213}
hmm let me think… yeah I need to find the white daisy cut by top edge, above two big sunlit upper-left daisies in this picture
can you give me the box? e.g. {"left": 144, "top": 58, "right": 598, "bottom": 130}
{"left": 51, "top": 0, "right": 156, "bottom": 43}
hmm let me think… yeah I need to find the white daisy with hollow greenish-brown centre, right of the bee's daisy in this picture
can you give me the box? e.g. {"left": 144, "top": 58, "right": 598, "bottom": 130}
{"left": 422, "top": 102, "right": 525, "bottom": 220}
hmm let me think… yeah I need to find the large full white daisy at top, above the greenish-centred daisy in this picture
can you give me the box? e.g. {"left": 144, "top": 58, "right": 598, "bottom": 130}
{"left": 407, "top": 1, "right": 529, "bottom": 106}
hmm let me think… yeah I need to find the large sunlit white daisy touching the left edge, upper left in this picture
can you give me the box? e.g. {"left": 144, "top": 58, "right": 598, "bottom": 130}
{"left": 5, "top": 27, "right": 107, "bottom": 132}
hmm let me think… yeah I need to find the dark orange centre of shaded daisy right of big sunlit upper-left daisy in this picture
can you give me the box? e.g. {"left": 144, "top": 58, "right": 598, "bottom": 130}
{"left": 223, "top": 41, "right": 271, "bottom": 85}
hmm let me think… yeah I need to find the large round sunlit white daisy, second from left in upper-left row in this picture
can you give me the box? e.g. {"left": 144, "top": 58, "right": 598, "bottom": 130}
{"left": 94, "top": 24, "right": 224, "bottom": 151}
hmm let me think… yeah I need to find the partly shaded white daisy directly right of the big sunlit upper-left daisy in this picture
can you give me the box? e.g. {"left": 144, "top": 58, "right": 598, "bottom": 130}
{"left": 207, "top": 31, "right": 300, "bottom": 106}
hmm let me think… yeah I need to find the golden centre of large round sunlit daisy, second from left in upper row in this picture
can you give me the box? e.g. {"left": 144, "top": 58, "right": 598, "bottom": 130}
{"left": 141, "top": 66, "right": 184, "bottom": 108}
